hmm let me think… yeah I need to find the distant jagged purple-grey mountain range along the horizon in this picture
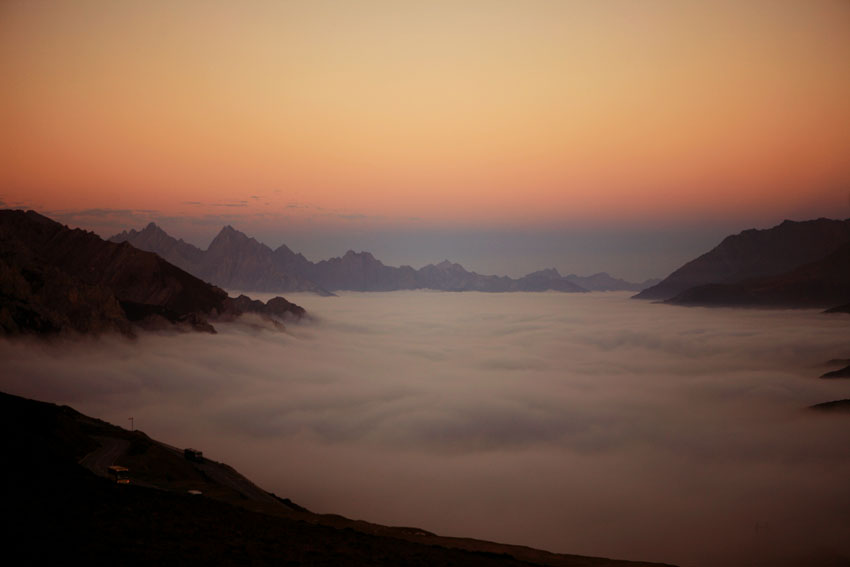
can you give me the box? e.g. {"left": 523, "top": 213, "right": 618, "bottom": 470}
{"left": 109, "top": 223, "right": 654, "bottom": 295}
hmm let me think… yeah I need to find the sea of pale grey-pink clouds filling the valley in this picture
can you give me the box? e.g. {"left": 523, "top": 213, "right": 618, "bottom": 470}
{"left": 0, "top": 291, "right": 850, "bottom": 566}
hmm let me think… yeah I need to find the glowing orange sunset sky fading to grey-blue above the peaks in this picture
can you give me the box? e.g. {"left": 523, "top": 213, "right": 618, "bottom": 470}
{"left": 0, "top": 0, "right": 850, "bottom": 279}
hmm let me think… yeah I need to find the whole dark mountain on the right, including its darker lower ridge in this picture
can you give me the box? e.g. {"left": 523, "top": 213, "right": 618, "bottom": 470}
{"left": 635, "top": 219, "right": 850, "bottom": 307}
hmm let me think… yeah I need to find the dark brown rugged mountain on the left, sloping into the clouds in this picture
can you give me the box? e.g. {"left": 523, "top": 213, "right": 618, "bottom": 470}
{"left": 0, "top": 210, "right": 304, "bottom": 335}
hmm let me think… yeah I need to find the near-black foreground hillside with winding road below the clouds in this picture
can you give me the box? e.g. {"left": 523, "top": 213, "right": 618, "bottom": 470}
{"left": 0, "top": 393, "right": 676, "bottom": 567}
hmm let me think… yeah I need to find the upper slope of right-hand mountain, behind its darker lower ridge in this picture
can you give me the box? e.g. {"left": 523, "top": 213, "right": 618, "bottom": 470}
{"left": 635, "top": 219, "right": 850, "bottom": 300}
